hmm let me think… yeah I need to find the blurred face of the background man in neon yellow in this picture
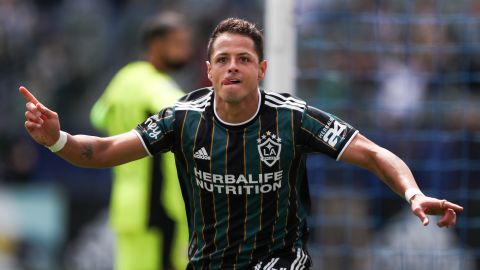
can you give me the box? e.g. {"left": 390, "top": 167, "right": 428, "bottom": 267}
{"left": 159, "top": 28, "right": 192, "bottom": 70}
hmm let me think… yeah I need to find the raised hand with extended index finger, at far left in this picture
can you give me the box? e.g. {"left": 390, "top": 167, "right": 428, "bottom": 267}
{"left": 18, "top": 86, "right": 60, "bottom": 146}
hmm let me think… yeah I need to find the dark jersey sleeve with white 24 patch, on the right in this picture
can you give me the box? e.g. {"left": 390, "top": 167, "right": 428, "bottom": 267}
{"left": 300, "top": 106, "right": 358, "bottom": 160}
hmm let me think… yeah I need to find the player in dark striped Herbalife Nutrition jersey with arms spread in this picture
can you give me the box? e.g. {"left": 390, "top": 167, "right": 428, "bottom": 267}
{"left": 20, "top": 19, "right": 463, "bottom": 269}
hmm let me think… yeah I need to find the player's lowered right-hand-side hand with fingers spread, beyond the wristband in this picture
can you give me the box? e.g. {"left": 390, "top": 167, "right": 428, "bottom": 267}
{"left": 411, "top": 194, "right": 463, "bottom": 228}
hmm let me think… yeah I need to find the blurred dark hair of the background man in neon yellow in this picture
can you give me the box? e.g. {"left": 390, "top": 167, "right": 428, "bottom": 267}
{"left": 142, "top": 11, "right": 187, "bottom": 46}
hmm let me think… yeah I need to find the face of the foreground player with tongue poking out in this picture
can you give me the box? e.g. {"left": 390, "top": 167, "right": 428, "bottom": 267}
{"left": 207, "top": 33, "right": 267, "bottom": 103}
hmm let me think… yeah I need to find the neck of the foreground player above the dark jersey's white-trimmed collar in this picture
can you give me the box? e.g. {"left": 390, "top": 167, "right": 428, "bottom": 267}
{"left": 214, "top": 91, "right": 260, "bottom": 125}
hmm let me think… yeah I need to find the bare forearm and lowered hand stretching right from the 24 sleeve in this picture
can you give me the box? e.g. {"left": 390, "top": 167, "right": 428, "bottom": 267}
{"left": 340, "top": 134, "right": 463, "bottom": 227}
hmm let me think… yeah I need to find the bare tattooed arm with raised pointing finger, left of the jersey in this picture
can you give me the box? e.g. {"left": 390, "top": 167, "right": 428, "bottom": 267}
{"left": 19, "top": 86, "right": 147, "bottom": 168}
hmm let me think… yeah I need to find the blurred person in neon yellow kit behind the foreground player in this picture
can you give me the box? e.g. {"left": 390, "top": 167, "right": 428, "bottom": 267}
{"left": 90, "top": 12, "right": 191, "bottom": 270}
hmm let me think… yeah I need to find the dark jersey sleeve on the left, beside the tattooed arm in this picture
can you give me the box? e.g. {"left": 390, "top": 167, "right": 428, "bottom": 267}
{"left": 134, "top": 107, "right": 175, "bottom": 156}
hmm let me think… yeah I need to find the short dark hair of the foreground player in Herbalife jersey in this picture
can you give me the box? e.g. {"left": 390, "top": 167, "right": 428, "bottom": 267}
{"left": 207, "top": 18, "right": 263, "bottom": 61}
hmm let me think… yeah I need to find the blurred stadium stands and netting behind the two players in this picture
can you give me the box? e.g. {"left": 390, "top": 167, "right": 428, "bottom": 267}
{"left": 0, "top": 0, "right": 480, "bottom": 270}
